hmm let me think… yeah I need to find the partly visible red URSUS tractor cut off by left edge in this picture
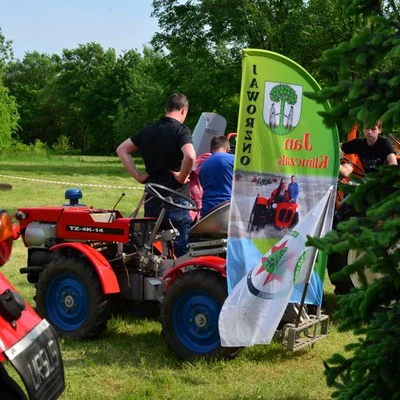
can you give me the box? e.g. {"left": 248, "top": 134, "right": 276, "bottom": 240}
{"left": 0, "top": 210, "right": 65, "bottom": 400}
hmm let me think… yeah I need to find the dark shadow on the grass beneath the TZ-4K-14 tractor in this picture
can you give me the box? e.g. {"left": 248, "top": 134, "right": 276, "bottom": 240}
{"left": 58, "top": 295, "right": 336, "bottom": 374}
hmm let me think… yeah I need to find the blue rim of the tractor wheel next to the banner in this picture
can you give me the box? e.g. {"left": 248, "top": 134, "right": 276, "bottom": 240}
{"left": 172, "top": 290, "right": 222, "bottom": 355}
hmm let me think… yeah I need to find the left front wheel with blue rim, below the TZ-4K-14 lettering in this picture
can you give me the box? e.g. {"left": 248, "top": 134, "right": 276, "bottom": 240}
{"left": 35, "top": 256, "right": 110, "bottom": 339}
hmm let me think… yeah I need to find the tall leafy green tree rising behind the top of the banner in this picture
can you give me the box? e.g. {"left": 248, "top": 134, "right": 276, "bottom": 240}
{"left": 152, "top": 0, "right": 305, "bottom": 131}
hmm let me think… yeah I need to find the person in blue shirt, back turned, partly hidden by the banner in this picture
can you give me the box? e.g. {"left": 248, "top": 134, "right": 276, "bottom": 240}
{"left": 200, "top": 136, "right": 234, "bottom": 217}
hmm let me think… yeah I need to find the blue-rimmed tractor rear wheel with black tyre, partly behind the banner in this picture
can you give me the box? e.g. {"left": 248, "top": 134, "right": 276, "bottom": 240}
{"left": 161, "top": 269, "right": 242, "bottom": 359}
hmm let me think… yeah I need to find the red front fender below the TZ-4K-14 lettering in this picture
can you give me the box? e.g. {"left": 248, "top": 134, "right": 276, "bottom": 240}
{"left": 50, "top": 243, "right": 121, "bottom": 294}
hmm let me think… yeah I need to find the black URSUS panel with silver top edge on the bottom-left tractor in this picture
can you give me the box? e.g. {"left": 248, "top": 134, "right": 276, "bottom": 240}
{"left": 5, "top": 319, "right": 65, "bottom": 400}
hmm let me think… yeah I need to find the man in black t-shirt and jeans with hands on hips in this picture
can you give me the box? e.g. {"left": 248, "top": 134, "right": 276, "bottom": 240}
{"left": 117, "top": 93, "right": 196, "bottom": 257}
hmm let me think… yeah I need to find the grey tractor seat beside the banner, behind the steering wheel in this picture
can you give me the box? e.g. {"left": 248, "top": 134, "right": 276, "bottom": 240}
{"left": 189, "top": 200, "right": 231, "bottom": 237}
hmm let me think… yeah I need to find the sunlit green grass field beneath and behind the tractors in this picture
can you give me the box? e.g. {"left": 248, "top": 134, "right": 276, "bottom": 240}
{"left": 0, "top": 157, "right": 356, "bottom": 400}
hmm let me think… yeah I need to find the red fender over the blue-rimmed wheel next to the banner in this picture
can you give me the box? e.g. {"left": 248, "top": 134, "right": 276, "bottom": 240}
{"left": 163, "top": 256, "right": 226, "bottom": 290}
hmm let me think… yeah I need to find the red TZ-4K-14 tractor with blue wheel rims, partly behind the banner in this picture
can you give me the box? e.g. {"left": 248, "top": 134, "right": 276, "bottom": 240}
{"left": 16, "top": 183, "right": 327, "bottom": 359}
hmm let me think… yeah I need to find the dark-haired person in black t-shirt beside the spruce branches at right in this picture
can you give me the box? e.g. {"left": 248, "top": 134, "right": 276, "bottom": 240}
{"left": 339, "top": 120, "right": 397, "bottom": 177}
